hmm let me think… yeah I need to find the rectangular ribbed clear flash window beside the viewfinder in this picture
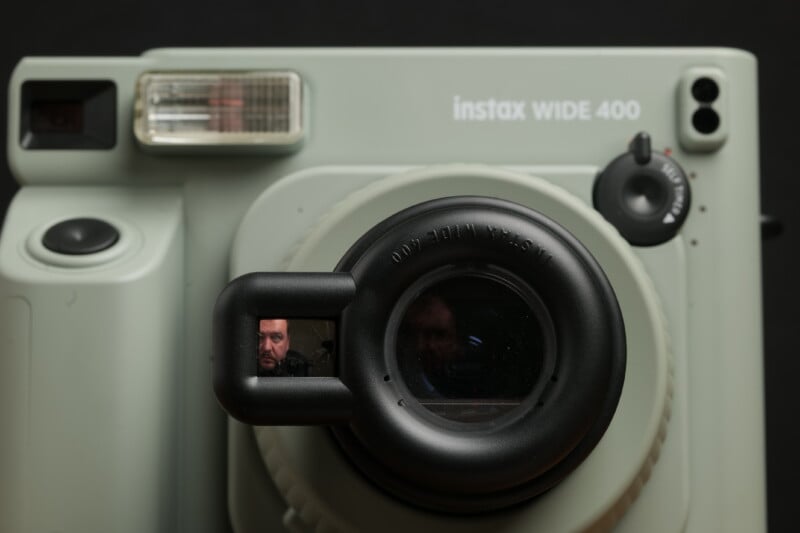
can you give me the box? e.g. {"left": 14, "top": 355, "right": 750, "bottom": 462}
{"left": 133, "top": 71, "right": 303, "bottom": 153}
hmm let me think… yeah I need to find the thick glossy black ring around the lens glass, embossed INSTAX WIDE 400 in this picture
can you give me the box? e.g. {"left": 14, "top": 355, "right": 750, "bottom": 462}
{"left": 332, "top": 197, "right": 625, "bottom": 513}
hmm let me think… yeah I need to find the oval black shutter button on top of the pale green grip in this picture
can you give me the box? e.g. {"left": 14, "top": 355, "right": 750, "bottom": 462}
{"left": 42, "top": 218, "right": 119, "bottom": 255}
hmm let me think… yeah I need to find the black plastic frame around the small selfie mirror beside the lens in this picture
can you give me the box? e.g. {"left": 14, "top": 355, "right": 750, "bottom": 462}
{"left": 212, "top": 273, "right": 356, "bottom": 425}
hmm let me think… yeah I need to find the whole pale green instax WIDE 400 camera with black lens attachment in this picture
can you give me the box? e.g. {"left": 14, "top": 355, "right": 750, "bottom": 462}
{"left": 0, "top": 49, "right": 765, "bottom": 533}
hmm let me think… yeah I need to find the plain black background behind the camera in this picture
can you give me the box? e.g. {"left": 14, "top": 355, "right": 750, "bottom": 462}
{"left": 0, "top": 0, "right": 800, "bottom": 532}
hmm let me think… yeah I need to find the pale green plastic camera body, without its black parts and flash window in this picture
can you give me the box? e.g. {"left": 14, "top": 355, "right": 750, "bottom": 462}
{"left": 0, "top": 48, "right": 766, "bottom": 533}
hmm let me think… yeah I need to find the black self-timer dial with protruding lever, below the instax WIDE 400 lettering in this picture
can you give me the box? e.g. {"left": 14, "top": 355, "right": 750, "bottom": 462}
{"left": 594, "top": 132, "right": 691, "bottom": 246}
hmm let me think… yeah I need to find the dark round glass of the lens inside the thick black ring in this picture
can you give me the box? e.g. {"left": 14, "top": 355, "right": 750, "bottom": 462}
{"left": 397, "top": 275, "right": 548, "bottom": 422}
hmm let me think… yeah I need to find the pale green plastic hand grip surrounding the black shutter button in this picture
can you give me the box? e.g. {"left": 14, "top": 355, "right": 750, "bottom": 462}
{"left": 0, "top": 187, "right": 183, "bottom": 533}
